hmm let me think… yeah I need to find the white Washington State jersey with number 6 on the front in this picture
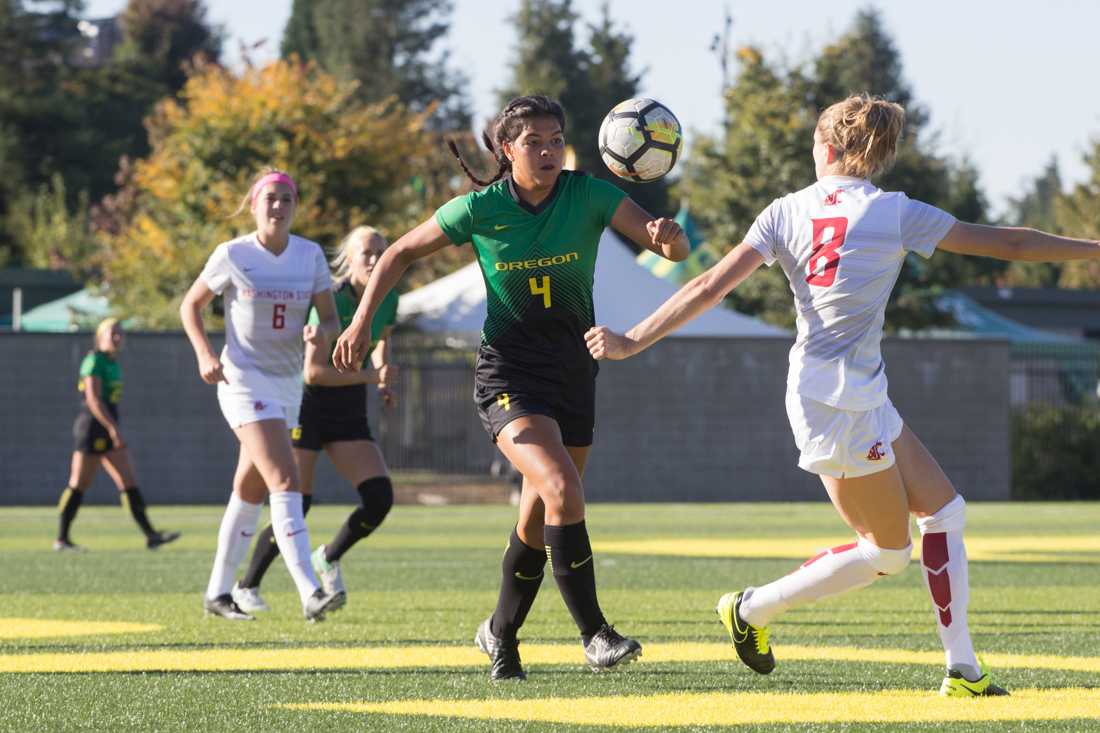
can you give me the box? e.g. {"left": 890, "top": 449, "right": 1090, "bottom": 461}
{"left": 200, "top": 233, "right": 332, "bottom": 406}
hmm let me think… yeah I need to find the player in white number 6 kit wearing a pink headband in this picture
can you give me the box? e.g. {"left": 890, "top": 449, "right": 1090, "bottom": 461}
{"left": 179, "top": 171, "right": 340, "bottom": 621}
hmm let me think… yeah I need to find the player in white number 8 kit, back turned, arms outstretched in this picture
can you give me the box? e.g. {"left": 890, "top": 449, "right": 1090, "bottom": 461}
{"left": 585, "top": 95, "right": 1100, "bottom": 697}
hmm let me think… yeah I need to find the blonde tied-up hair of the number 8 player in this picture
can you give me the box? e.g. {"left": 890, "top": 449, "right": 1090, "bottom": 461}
{"left": 817, "top": 94, "right": 905, "bottom": 178}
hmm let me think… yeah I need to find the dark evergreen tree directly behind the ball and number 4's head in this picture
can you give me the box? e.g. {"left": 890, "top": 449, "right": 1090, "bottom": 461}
{"left": 498, "top": 0, "right": 671, "bottom": 216}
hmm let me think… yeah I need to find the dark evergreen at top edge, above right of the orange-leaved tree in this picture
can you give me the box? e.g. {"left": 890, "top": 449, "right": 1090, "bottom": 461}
{"left": 282, "top": 0, "right": 470, "bottom": 130}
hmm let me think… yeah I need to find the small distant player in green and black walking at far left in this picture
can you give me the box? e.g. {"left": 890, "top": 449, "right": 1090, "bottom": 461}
{"left": 54, "top": 318, "right": 179, "bottom": 551}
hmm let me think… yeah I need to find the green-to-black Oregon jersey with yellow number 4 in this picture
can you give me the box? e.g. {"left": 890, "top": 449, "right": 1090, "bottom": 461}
{"left": 436, "top": 171, "right": 626, "bottom": 363}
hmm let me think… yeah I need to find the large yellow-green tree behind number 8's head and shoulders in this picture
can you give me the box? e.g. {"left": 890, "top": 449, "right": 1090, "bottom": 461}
{"left": 679, "top": 10, "right": 1003, "bottom": 329}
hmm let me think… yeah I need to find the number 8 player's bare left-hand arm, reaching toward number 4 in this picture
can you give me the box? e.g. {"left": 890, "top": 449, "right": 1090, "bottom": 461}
{"left": 584, "top": 243, "right": 763, "bottom": 359}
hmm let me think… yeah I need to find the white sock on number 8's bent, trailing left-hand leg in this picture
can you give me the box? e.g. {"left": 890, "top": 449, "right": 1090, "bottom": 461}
{"left": 740, "top": 537, "right": 912, "bottom": 627}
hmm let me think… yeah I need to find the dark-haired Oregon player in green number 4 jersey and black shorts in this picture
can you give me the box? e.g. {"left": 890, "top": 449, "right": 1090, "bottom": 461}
{"left": 333, "top": 96, "right": 689, "bottom": 679}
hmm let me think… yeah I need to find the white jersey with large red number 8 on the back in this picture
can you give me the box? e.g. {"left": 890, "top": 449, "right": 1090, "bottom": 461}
{"left": 745, "top": 176, "right": 955, "bottom": 411}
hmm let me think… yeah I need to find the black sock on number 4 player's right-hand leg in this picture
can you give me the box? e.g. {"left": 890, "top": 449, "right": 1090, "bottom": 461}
{"left": 542, "top": 521, "right": 607, "bottom": 642}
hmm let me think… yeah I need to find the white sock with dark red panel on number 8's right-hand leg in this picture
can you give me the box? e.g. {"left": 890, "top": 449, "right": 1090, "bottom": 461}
{"left": 916, "top": 495, "right": 980, "bottom": 679}
